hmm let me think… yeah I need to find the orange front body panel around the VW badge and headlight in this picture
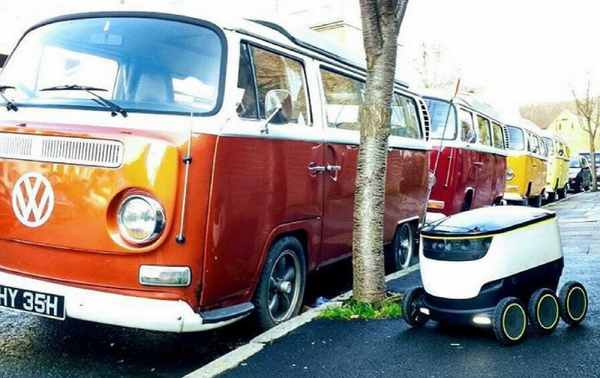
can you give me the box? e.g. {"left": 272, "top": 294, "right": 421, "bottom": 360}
{"left": 0, "top": 124, "right": 216, "bottom": 306}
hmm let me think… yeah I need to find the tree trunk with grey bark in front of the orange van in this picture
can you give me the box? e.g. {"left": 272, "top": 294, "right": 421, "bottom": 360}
{"left": 352, "top": 0, "right": 408, "bottom": 304}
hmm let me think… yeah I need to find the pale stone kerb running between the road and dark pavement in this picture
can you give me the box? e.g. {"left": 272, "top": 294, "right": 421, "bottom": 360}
{"left": 183, "top": 264, "right": 419, "bottom": 378}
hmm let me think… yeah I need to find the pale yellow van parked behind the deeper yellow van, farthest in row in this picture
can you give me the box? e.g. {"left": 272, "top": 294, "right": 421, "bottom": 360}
{"left": 542, "top": 130, "right": 570, "bottom": 202}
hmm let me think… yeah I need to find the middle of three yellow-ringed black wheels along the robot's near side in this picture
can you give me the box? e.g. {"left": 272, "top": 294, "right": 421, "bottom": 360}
{"left": 527, "top": 288, "right": 560, "bottom": 335}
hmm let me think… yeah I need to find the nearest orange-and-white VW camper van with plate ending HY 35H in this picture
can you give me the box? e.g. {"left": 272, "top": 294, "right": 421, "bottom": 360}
{"left": 0, "top": 11, "right": 430, "bottom": 332}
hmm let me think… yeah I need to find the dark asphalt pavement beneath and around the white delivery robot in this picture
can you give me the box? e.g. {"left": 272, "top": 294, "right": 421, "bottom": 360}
{"left": 219, "top": 193, "right": 600, "bottom": 378}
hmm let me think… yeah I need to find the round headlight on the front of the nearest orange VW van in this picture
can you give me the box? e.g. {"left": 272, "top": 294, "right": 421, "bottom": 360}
{"left": 117, "top": 194, "right": 165, "bottom": 244}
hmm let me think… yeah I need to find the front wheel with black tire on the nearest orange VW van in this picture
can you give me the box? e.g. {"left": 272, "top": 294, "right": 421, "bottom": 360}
{"left": 252, "top": 236, "right": 306, "bottom": 330}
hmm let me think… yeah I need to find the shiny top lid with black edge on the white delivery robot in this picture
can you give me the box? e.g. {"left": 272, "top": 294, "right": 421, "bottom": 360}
{"left": 421, "top": 206, "right": 556, "bottom": 237}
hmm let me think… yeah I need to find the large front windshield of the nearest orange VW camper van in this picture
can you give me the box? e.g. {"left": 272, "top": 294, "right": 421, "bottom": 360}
{"left": 0, "top": 17, "right": 223, "bottom": 115}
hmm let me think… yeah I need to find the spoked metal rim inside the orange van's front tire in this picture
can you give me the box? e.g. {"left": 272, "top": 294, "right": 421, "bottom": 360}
{"left": 269, "top": 250, "right": 301, "bottom": 323}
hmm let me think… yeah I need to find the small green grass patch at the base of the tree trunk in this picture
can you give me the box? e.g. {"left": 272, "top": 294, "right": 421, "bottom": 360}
{"left": 319, "top": 293, "right": 404, "bottom": 320}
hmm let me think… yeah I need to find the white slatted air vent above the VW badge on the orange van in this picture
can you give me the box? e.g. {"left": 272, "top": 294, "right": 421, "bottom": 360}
{"left": 0, "top": 134, "right": 123, "bottom": 168}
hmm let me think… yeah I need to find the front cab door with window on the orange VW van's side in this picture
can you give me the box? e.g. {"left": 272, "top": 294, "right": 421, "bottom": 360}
{"left": 201, "top": 43, "right": 323, "bottom": 305}
